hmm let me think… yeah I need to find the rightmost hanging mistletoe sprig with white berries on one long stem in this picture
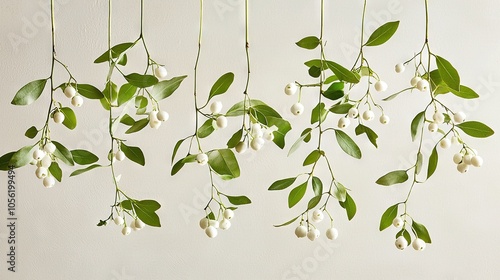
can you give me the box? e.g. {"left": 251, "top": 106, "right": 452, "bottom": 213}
{"left": 377, "top": 0, "right": 494, "bottom": 251}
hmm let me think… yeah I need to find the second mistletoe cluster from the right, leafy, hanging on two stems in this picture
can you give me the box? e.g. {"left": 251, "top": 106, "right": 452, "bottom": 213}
{"left": 269, "top": 0, "right": 399, "bottom": 241}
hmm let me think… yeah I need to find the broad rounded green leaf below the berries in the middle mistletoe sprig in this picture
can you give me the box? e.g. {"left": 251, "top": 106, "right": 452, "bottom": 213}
{"left": 208, "top": 149, "right": 240, "bottom": 180}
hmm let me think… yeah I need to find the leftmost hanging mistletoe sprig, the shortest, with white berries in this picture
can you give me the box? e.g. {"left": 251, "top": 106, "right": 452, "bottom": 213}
{"left": 0, "top": 0, "right": 102, "bottom": 188}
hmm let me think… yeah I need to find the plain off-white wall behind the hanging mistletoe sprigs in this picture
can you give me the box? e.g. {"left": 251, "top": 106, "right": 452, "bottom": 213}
{"left": 0, "top": 0, "right": 500, "bottom": 280}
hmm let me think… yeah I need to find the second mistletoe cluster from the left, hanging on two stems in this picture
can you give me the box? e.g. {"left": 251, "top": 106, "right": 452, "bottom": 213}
{"left": 71, "top": 0, "right": 186, "bottom": 235}
